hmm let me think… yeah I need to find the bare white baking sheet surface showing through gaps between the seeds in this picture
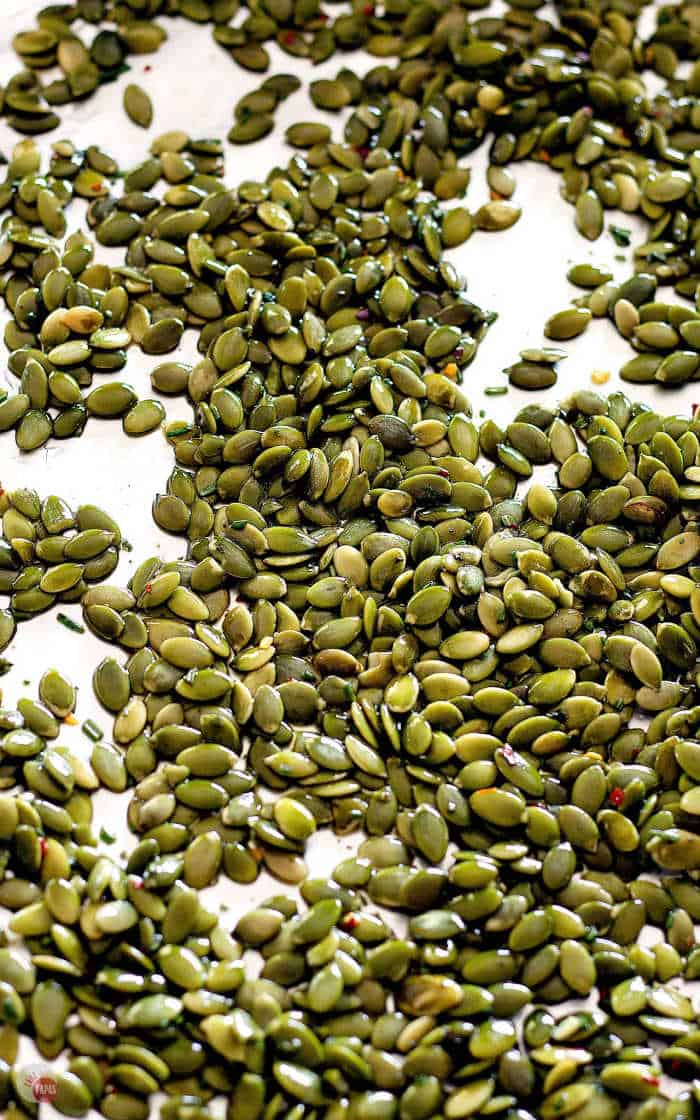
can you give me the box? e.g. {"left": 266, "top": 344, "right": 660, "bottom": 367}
{"left": 0, "top": 0, "right": 700, "bottom": 1116}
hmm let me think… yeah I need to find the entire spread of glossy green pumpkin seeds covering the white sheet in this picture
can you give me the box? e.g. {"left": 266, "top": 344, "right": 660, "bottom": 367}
{"left": 0, "top": 0, "right": 700, "bottom": 1120}
